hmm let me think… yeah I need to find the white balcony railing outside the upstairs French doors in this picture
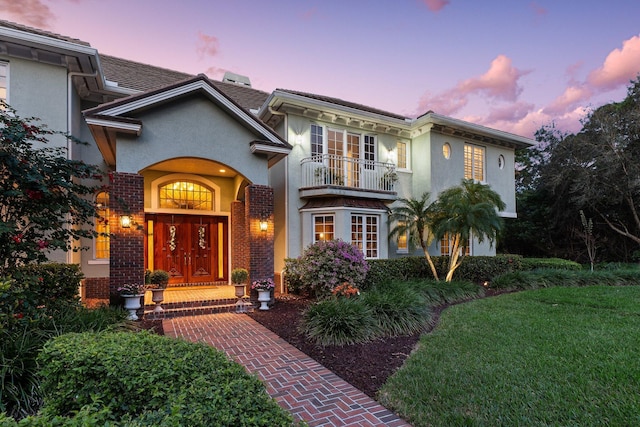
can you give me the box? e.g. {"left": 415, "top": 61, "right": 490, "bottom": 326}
{"left": 300, "top": 154, "right": 398, "bottom": 192}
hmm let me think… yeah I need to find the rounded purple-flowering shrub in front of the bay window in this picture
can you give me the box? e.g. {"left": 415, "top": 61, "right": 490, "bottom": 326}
{"left": 287, "top": 240, "right": 369, "bottom": 298}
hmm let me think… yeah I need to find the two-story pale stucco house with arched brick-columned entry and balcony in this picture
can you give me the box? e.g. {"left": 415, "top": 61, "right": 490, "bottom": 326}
{"left": 0, "top": 21, "right": 533, "bottom": 298}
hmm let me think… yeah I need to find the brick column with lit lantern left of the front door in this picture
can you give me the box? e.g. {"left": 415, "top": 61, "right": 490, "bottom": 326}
{"left": 109, "top": 172, "right": 145, "bottom": 302}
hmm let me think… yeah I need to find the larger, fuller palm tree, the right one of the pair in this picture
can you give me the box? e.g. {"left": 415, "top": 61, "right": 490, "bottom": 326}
{"left": 433, "top": 179, "right": 506, "bottom": 282}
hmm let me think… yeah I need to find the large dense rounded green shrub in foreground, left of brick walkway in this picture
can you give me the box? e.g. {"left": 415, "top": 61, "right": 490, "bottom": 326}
{"left": 38, "top": 331, "right": 293, "bottom": 426}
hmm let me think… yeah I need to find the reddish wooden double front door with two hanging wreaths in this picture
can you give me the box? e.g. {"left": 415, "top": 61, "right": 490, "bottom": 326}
{"left": 147, "top": 214, "right": 229, "bottom": 284}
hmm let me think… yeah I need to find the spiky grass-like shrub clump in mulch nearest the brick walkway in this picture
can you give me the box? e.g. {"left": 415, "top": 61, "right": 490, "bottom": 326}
{"left": 300, "top": 298, "right": 380, "bottom": 346}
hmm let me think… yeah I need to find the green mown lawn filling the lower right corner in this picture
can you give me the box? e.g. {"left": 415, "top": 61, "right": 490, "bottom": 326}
{"left": 380, "top": 286, "right": 640, "bottom": 427}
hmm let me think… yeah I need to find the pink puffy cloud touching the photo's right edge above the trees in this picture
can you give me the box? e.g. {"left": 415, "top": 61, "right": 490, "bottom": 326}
{"left": 587, "top": 35, "right": 640, "bottom": 91}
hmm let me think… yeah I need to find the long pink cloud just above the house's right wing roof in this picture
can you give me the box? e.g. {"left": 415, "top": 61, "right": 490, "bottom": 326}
{"left": 416, "top": 55, "right": 529, "bottom": 115}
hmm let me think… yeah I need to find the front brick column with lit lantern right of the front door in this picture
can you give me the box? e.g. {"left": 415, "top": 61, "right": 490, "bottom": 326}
{"left": 244, "top": 185, "right": 274, "bottom": 301}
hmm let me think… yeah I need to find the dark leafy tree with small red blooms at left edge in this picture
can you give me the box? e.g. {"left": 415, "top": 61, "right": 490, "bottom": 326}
{"left": 0, "top": 104, "right": 102, "bottom": 276}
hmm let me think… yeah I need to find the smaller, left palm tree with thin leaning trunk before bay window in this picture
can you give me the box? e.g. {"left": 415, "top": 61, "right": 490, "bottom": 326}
{"left": 389, "top": 193, "right": 439, "bottom": 280}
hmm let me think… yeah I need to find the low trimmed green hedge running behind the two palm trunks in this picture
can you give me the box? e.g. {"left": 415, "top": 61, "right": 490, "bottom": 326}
{"left": 364, "top": 255, "right": 523, "bottom": 289}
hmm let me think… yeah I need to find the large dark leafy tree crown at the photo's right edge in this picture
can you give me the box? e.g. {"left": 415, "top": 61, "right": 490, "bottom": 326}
{"left": 548, "top": 76, "right": 640, "bottom": 251}
